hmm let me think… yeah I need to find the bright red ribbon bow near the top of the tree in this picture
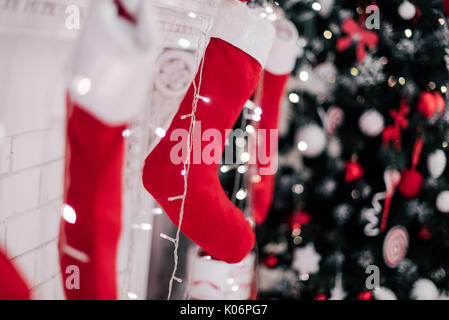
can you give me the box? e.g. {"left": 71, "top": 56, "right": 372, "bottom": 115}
{"left": 337, "top": 18, "right": 379, "bottom": 62}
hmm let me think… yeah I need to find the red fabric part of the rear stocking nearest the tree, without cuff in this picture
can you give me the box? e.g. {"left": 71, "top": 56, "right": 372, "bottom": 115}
{"left": 250, "top": 70, "right": 290, "bottom": 224}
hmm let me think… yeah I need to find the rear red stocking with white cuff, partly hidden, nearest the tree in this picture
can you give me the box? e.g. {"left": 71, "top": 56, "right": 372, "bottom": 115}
{"left": 250, "top": 20, "right": 298, "bottom": 224}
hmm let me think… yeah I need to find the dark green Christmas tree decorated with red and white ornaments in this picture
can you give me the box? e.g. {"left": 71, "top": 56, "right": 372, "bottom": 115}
{"left": 250, "top": 0, "right": 449, "bottom": 300}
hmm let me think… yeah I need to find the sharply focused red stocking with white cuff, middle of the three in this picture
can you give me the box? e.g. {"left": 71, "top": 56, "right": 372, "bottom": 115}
{"left": 143, "top": 0, "right": 275, "bottom": 263}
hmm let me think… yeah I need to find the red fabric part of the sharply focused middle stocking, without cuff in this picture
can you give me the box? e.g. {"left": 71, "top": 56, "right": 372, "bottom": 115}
{"left": 143, "top": 38, "right": 261, "bottom": 263}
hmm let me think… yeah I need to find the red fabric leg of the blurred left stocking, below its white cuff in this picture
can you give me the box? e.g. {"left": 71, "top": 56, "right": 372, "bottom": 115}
{"left": 59, "top": 97, "right": 126, "bottom": 300}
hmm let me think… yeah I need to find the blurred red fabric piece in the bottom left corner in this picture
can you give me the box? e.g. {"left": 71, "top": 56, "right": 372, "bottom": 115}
{"left": 0, "top": 250, "right": 30, "bottom": 300}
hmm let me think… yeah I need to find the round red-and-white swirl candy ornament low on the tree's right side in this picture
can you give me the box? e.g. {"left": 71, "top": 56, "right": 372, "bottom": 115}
{"left": 383, "top": 226, "right": 409, "bottom": 268}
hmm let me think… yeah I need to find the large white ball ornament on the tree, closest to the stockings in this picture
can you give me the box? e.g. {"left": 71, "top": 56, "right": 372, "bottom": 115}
{"left": 296, "top": 123, "right": 327, "bottom": 158}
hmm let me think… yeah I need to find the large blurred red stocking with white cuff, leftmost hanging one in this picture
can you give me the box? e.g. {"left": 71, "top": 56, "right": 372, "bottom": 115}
{"left": 59, "top": 0, "right": 159, "bottom": 299}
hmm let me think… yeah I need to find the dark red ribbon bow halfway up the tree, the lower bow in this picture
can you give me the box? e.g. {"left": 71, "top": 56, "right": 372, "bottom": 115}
{"left": 382, "top": 98, "right": 410, "bottom": 151}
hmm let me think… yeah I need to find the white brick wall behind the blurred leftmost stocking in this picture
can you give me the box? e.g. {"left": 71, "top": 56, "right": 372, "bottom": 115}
{"left": 0, "top": 0, "right": 151, "bottom": 299}
